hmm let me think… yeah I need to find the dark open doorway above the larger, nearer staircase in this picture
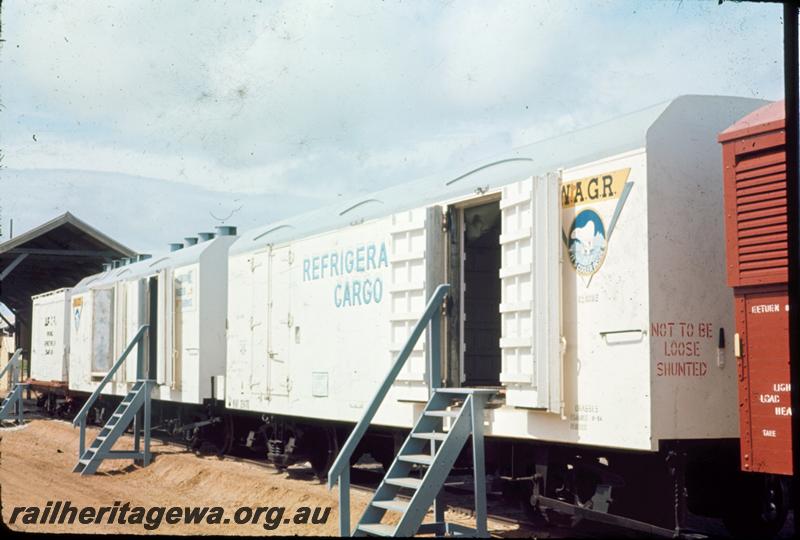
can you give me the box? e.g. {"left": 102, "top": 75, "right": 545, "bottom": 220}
{"left": 462, "top": 201, "right": 501, "bottom": 386}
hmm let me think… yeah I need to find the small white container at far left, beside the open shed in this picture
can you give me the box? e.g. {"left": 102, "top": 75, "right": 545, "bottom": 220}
{"left": 30, "top": 289, "right": 70, "bottom": 382}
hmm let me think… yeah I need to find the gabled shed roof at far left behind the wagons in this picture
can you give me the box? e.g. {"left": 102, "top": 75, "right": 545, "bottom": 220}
{"left": 0, "top": 212, "right": 136, "bottom": 313}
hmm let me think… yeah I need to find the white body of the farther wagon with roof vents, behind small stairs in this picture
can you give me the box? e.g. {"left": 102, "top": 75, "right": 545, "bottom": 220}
{"left": 69, "top": 236, "right": 235, "bottom": 404}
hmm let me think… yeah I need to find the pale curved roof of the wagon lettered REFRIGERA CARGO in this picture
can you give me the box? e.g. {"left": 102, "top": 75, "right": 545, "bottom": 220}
{"left": 231, "top": 96, "right": 765, "bottom": 254}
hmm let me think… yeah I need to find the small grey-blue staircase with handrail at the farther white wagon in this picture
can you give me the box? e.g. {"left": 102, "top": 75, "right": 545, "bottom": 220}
{"left": 72, "top": 325, "right": 155, "bottom": 475}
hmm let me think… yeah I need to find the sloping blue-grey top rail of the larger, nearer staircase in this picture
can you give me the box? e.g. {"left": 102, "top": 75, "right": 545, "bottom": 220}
{"left": 328, "top": 283, "right": 450, "bottom": 490}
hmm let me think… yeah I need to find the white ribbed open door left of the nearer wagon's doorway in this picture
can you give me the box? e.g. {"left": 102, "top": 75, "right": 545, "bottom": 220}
{"left": 389, "top": 206, "right": 444, "bottom": 401}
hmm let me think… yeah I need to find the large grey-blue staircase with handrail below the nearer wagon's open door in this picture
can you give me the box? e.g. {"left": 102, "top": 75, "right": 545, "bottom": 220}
{"left": 328, "top": 284, "right": 495, "bottom": 537}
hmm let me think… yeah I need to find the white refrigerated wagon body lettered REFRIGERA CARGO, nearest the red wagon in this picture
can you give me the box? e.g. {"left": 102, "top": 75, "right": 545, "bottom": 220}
{"left": 226, "top": 96, "right": 764, "bottom": 450}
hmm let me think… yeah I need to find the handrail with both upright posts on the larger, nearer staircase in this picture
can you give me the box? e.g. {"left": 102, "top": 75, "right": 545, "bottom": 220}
{"left": 328, "top": 283, "right": 450, "bottom": 536}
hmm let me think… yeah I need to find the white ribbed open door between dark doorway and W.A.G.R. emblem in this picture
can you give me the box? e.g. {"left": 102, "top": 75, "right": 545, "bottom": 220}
{"left": 500, "top": 173, "right": 563, "bottom": 413}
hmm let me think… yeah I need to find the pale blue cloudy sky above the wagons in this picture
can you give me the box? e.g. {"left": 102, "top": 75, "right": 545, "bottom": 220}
{"left": 0, "top": 0, "right": 783, "bottom": 249}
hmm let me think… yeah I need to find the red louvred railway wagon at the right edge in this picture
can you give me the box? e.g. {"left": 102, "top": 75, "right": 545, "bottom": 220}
{"left": 719, "top": 101, "right": 792, "bottom": 475}
